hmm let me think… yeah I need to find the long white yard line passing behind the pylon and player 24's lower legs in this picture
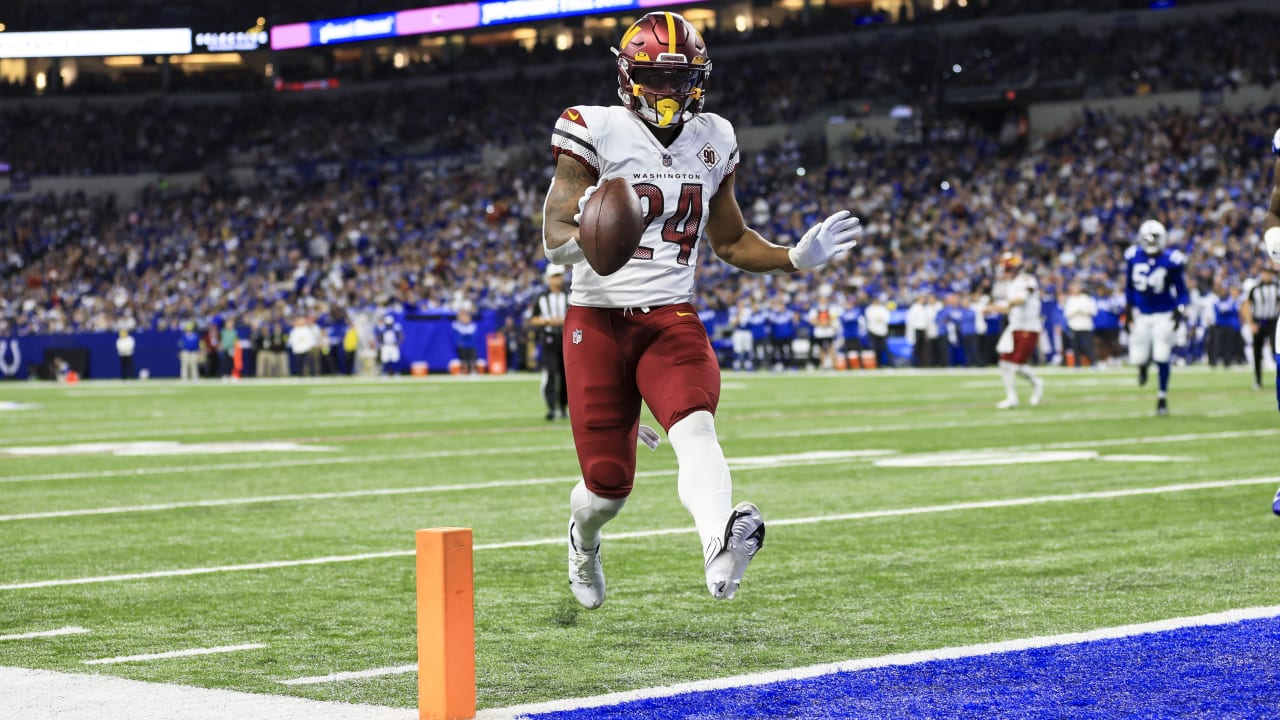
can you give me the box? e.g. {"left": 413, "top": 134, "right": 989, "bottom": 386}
{"left": 0, "top": 475, "right": 1280, "bottom": 591}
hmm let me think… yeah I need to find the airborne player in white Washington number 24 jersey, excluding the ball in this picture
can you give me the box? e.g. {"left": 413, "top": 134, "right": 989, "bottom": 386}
{"left": 543, "top": 12, "right": 861, "bottom": 609}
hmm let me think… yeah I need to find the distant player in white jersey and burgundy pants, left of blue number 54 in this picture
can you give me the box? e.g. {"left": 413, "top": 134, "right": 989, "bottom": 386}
{"left": 992, "top": 252, "right": 1044, "bottom": 410}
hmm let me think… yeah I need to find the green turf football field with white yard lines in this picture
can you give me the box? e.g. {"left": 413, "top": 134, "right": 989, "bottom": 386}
{"left": 0, "top": 368, "right": 1280, "bottom": 708}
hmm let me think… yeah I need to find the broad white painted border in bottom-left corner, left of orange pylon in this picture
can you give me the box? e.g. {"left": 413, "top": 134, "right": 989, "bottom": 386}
{"left": 0, "top": 667, "right": 417, "bottom": 720}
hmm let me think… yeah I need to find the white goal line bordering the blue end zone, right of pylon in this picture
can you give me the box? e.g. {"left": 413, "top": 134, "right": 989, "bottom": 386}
{"left": 476, "top": 605, "right": 1280, "bottom": 720}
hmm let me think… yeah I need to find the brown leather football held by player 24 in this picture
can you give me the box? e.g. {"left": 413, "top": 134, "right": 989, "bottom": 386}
{"left": 577, "top": 178, "right": 645, "bottom": 275}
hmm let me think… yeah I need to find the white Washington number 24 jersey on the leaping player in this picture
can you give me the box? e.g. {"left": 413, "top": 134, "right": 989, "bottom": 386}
{"left": 552, "top": 105, "right": 739, "bottom": 307}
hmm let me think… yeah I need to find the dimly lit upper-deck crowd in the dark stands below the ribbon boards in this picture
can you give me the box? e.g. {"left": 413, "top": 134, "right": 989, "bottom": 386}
{"left": 0, "top": 7, "right": 1280, "bottom": 176}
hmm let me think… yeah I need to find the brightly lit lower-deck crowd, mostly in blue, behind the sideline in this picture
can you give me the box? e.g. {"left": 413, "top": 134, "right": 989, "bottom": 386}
{"left": 0, "top": 98, "right": 1280, "bottom": 368}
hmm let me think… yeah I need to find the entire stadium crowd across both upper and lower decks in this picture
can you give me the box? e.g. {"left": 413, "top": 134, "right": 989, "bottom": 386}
{"left": 0, "top": 3, "right": 1280, "bottom": 371}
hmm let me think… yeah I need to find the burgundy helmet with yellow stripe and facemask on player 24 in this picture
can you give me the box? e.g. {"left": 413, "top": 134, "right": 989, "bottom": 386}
{"left": 613, "top": 12, "right": 712, "bottom": 128}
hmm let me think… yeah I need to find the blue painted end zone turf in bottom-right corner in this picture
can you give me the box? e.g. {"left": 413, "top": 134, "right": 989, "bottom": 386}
{"left": 529, "top": 609, "right": 1280, "bottom": 720}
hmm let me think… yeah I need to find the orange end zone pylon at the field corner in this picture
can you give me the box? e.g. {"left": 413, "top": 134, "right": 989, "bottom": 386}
{"left": 416, "top": 528, "right": 476, "bottom": 720}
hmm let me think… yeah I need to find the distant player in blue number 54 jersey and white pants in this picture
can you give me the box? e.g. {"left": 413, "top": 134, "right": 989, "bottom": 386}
{"left": 1124, "top": 220, "right": 1190, "bottom": 415}
